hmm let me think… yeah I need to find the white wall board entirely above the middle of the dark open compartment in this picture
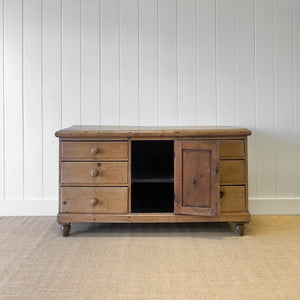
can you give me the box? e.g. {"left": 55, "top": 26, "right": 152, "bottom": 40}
{"left": 139, "top": 0, "right": 159, "bottom": 125}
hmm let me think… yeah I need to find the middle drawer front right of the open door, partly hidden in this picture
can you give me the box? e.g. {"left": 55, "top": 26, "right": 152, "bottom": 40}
{"left": 220, "top": 159, "right": 246, "bottom": 184}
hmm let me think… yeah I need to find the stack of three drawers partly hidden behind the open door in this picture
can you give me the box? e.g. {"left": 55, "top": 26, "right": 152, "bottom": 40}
{"left": 219, "top": 139, "right": 248, "bottom": 213}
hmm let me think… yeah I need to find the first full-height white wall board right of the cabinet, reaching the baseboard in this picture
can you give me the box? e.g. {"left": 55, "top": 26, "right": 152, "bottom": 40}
{"left": 255, "top": 0, "right": 276, "bottom": 198}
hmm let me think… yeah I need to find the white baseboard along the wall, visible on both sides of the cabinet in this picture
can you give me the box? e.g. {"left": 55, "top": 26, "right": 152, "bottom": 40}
{"left": 0, "top": 198, "right": 300, "bottom": 216}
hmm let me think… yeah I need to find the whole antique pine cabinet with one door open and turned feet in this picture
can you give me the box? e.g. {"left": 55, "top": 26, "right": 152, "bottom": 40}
{"left": 55, "top": 126, "right": 251, "bottom": 236}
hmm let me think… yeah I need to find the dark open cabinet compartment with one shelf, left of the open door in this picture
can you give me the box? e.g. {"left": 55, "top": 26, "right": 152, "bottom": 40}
{"left": 131, "top": 141, "right": 174, "bottom": 213}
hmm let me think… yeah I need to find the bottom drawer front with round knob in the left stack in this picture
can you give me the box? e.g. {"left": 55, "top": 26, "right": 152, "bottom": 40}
{"left": 60, "top": 187, "right": 128, "bottom": 214}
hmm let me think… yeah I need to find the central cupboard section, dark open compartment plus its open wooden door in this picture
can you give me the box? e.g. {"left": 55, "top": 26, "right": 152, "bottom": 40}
{"left": 131, "top": 140, "right": 220, "bottom": 216}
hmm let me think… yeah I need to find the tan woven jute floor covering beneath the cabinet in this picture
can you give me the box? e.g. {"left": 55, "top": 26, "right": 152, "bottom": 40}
{"left": 0, "top": 216, "right": 300, "bottom": 300}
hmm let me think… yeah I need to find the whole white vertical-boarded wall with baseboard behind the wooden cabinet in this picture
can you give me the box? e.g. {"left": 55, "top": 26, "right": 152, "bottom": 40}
{"left": 0, "top": 0, "right": 300, "bottom": 215}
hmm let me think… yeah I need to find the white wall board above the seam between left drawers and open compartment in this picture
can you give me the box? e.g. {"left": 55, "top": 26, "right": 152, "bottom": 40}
{"left": 120, "top": 0, "right": 139, "bottom": 125}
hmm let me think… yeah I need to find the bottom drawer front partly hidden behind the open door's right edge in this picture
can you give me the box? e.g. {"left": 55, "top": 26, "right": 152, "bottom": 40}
{"left": 220, "top": 186, "right": 246, "bottom": 213}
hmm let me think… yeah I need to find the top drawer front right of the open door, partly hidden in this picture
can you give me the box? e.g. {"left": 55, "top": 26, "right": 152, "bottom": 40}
{"left": 219, "top": 140, "right": 245, "bottom": 159}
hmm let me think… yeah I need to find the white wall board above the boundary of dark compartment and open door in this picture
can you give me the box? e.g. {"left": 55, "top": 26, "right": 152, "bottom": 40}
{"left": 158, "top": 0, "right": 178, "bottom": 126}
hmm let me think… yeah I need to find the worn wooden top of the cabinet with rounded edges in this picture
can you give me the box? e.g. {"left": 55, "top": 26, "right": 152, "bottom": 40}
{"left": 55, "top": 125, "right": 251, "bottom": 138}
